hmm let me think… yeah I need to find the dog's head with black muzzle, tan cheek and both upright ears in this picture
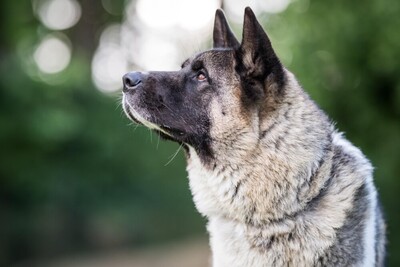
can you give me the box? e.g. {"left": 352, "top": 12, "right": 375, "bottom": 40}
{"left": 123, "top": 8, "right": 286, "bottom": 162}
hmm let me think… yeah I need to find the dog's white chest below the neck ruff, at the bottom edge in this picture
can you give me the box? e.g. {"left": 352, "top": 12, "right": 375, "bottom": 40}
{"left": 207, "top": 218, "right": 327, "bottom": 267}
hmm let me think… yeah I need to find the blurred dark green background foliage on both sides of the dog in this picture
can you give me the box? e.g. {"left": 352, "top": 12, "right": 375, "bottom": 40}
{"left": 0, "top": 0, "right": 400, "bottom": 266}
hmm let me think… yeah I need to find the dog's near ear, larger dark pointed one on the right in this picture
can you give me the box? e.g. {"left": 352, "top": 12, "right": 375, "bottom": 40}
{"left": 238, "top": 7, "right": 284, "bottom": 85}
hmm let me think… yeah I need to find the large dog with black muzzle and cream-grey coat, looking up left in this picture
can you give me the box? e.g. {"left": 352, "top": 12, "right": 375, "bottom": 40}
{"left": 122, "top": 7, "right": 385, "bottom": 267}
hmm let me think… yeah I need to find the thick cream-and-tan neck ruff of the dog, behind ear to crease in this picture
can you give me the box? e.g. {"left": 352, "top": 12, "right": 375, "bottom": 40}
{"left": 188, "top": 73, "right": 333, "bottom": 225}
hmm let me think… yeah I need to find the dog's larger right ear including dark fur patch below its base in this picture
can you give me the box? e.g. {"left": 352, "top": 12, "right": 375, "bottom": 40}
{"left": 236, "top": 7, "right": 285, "bottom": 101}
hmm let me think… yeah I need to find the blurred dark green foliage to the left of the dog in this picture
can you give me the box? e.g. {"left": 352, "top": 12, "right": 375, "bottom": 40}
{"left": 0, "top": 1, "right": 204, "bottom": 266}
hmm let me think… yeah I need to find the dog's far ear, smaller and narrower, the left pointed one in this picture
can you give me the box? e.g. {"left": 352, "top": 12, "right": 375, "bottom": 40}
{"left": 213, "top": 9, "right": 240, "bottom": 48}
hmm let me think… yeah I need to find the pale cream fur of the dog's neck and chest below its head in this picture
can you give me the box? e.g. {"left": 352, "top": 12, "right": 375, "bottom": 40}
{"left": 187, "top": 72, "right": 370, "bottom": 266}
